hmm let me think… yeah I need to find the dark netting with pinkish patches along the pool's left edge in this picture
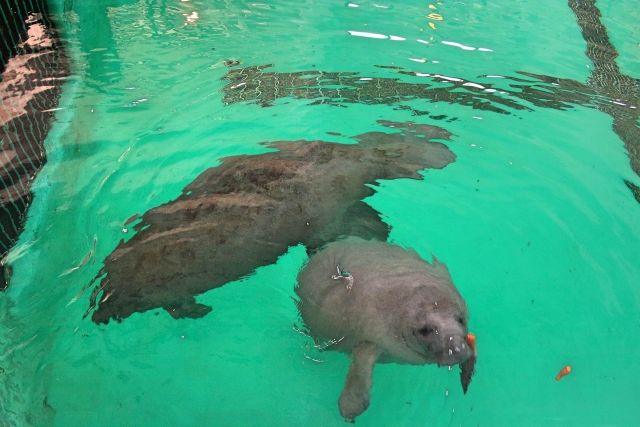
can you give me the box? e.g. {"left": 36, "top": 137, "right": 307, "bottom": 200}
{"left": 0, "top": 0, "right": 68, "bottom": 289}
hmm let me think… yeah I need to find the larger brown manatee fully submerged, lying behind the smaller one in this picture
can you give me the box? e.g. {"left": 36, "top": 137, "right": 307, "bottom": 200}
{"left": 87, "top": 121, "right": 455, "bottom": 323}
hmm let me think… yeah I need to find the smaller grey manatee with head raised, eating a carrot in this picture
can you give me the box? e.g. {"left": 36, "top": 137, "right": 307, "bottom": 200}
{"left": 296, "top": 237, "right": 472, "bottom": 420}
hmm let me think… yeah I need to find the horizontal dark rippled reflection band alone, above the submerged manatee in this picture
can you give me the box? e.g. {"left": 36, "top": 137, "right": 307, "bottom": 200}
{"left": 223, "top": 65, "right": 593, "bottom": 119}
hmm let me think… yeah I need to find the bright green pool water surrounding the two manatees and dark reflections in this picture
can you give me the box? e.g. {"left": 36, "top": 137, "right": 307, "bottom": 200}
{"left": 0, "top": 0, "right": 640, "bottom": 427}
